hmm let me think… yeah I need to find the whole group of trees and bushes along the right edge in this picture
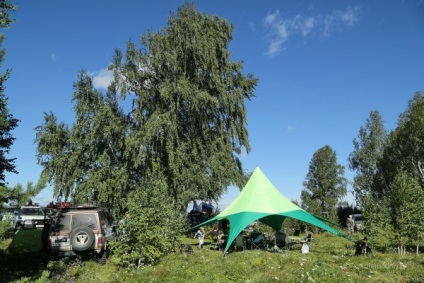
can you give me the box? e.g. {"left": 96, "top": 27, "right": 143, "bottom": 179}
{"left": 349, "top": 96, "right": 424, "bottom": 252}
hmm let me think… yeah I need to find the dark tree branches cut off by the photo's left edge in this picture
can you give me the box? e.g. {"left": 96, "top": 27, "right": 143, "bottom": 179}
{"left": 0, "top": 0, "right": 19, "bottom": 189}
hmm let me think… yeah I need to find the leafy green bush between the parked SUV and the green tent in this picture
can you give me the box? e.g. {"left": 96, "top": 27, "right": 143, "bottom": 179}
{"left": 113, "top": 169, "right": 185, "bottom": 266}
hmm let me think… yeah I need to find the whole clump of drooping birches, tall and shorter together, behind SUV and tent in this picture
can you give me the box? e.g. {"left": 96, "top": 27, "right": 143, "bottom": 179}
{"left": 36, "top": 4, "right": 257, "bottom": 215}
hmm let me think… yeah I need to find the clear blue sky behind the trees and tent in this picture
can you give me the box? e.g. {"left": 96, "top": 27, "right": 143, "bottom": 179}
{"left": 2, "top": 0, "right": 424, "bottom": 211}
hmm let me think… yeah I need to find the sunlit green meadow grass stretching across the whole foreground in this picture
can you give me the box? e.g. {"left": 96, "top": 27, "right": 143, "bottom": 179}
{"left": 0, "top": 233, "right": 424, "bottom": 283}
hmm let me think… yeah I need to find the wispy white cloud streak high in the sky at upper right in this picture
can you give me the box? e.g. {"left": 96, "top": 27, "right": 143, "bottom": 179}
{"left": 263, "top": 6, "right": 360, "bottom": 56}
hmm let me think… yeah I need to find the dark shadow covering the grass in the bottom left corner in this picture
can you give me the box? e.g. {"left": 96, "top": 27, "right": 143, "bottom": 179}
{"left": 0, "top": 230, "right": 50, "bottom": 282}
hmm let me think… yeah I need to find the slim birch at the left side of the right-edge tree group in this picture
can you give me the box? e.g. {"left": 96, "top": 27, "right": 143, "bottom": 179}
{"left": 348, "top": 110, "right": 387, "bottom": 206}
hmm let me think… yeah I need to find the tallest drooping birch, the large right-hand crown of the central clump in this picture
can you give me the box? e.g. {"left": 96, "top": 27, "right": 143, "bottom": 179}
{"left": 111, "top": 4, "right": 258, "bottom": 211}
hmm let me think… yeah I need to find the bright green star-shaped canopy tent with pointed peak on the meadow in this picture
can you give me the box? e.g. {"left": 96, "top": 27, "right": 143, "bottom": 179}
{"left": 190, "top": 167, "right": 350, "bottom": 253}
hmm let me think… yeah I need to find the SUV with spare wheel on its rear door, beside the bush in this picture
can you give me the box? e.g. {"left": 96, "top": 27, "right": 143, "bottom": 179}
{"left": 47, "top": 205, "right": 115, "bottom": 264}
